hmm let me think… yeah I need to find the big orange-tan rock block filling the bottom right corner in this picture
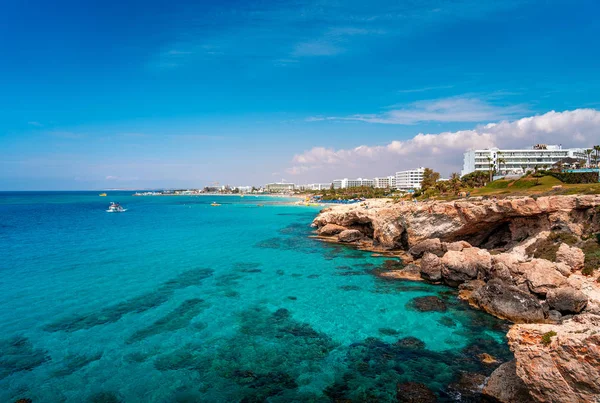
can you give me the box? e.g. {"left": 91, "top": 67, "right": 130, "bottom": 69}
{"left": 507, "top": 314, "right": 600, "bottom": 403}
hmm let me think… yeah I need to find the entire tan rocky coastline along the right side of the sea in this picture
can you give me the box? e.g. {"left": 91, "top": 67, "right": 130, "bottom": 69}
{"left": 313, "top": 195, "right": 600, "bottom": 403}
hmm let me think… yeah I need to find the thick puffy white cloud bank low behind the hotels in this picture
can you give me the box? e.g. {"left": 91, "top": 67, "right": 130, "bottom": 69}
{"left": 287, "top": 109, "right": 600, "bottom": 181}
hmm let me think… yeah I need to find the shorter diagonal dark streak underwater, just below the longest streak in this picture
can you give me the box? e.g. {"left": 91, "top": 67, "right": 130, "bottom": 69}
{"left": 127, "top": 298, "right": 210, "bottom": 344}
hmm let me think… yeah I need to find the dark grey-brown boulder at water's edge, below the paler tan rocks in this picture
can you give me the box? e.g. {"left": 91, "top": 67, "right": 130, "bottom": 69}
{"left": 470, "top": 279, "right": 544, "bottom": 323}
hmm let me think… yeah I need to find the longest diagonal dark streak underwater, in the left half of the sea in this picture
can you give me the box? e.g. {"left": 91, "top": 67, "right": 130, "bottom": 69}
{"left": 44, "top": 269, "right": 213, "bottom": 332}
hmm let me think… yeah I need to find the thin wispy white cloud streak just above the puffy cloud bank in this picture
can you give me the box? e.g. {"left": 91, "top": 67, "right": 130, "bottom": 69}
{"left": 307, "top": 96, "right": 527, "bottom": 125}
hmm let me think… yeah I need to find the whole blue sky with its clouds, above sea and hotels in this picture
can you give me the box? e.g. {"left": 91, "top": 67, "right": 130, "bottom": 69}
{"left": 0, "top": 0, "right": 600, "bottom": 190}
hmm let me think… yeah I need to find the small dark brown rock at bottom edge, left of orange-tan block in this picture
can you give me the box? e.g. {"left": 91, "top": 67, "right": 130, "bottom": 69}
{"left": 483, "top": 360, "right": 531, "bottom": 403}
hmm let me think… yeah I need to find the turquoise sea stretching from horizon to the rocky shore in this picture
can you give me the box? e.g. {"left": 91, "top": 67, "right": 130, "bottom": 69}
{"left": 0, "top": 192, "right": 511, "bottom": 403}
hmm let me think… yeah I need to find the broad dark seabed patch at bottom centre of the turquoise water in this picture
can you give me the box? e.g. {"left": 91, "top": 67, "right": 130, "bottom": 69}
{"left": 154, "top": 307, "right": 338, "bottom": 402}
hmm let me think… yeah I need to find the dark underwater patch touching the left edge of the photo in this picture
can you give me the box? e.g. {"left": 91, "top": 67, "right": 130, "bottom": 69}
{"left": 0, "top": 336, "right": 50, "bottom": 379}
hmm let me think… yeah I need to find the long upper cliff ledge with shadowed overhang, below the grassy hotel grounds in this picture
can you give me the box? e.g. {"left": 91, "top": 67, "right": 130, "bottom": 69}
{"left": 313, "top": 195, "right": 600, "bottom": 250}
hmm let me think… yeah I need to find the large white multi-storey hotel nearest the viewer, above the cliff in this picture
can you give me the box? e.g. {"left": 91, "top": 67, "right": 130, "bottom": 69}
{"left": 461, "top": 144, "right": 587, "bottom": 176}
